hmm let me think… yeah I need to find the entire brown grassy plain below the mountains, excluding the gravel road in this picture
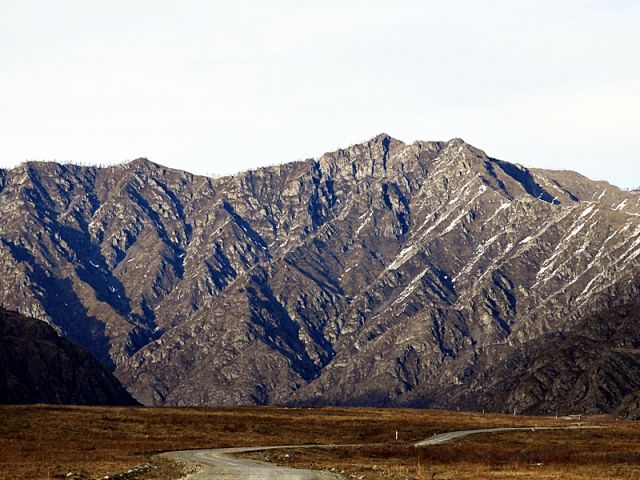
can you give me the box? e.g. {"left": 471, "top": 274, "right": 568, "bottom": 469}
{"left": 0, "top": 406, "right": 640, "bottom": 480}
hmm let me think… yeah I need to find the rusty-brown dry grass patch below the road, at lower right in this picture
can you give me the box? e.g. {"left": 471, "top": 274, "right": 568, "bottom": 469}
{"left": 252, "top": 419, "right": 640, "bottom": 480}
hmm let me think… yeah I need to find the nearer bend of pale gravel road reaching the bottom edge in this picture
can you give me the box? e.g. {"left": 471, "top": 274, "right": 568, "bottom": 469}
{"left": 161, "top": 445, "right": 342, "bottom": 480}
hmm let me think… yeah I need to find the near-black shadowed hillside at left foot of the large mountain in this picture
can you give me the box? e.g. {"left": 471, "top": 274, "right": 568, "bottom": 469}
{"left": 0, "top": 309, "right": 138, "bottom": 405}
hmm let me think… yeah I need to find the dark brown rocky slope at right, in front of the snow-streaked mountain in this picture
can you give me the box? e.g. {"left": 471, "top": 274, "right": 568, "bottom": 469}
{"left": 448, "top": 303, "right": 640, "bottom": 414}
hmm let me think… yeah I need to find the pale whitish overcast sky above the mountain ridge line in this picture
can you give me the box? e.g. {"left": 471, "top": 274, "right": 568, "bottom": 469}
{"left": 0, "top": 0, "right": 640, "bottom": 187}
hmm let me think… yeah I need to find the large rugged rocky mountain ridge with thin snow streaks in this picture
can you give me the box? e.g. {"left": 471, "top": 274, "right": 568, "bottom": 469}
{"left": 0, "top": 134, "right": 640, "bottom": 410}
